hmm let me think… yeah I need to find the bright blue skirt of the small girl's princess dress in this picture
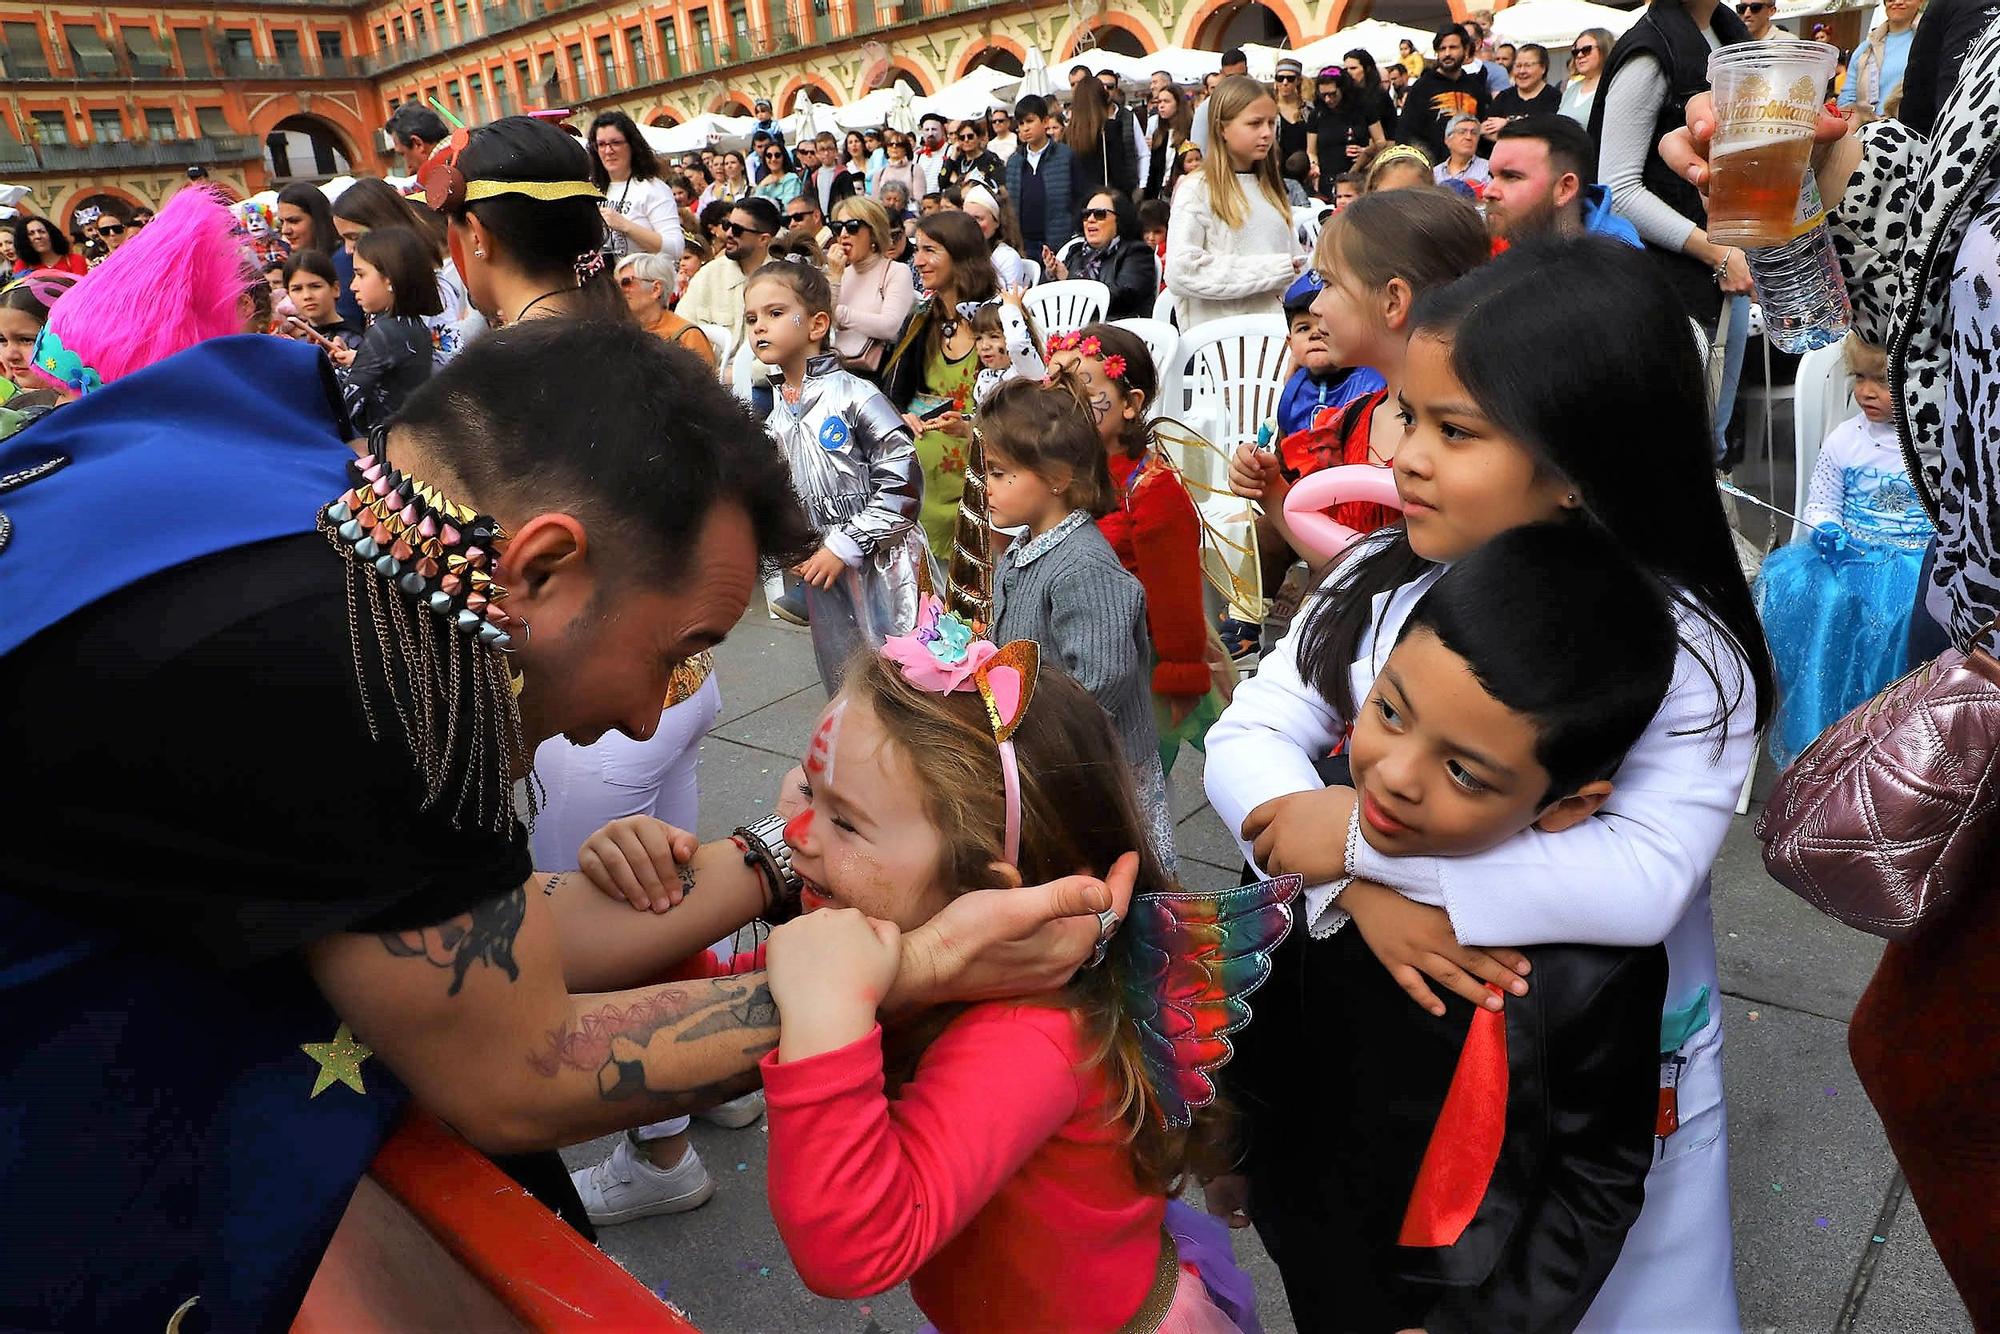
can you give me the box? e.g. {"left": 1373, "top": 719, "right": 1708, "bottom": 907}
{"left": 1756, "top": 542, "right": 1924, "bottom": 766}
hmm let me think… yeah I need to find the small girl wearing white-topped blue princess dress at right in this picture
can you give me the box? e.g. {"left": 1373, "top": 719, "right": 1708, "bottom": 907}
{"left": 1756, "top": 334, "right": 1932, "bottom": 764}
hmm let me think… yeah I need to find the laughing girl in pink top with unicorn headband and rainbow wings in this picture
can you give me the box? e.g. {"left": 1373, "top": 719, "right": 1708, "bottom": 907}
{"left": 762, "top": 612, "right": 1292, "bottom": 1334}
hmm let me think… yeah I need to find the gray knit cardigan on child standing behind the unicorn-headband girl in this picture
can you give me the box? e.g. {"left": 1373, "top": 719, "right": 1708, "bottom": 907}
{"left": 992, "top": 510, "right": 1160, "bottom": 768}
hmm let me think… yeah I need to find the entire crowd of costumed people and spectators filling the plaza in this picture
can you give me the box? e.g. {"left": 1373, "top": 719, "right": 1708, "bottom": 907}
{"left": 0, "top": 0, "right": 2000, "bottom": 1334}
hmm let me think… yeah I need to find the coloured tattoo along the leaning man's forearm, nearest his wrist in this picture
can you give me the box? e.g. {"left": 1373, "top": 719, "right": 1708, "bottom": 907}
{"left": 528, "top": 974, "right": 778, "bottom": 1106}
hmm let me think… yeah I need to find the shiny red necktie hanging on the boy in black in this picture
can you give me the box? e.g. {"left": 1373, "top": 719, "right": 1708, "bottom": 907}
{"left": 1396, "top": 988, "right": 1506, "bottom": 1246}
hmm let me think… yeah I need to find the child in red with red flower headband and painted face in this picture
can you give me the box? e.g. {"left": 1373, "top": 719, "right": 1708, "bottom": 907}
{"left": 1048, "top": 324, "right": 1228, "bottom": 772}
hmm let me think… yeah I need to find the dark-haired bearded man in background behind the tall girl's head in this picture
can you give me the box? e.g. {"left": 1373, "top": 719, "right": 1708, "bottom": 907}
{"left": 1486, "top": 116, "right": 1644, "bottom": 254}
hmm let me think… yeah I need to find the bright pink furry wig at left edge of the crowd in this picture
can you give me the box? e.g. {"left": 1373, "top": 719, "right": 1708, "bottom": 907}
{"left": 36, "top": 186, "right": 264, "bottom": 388}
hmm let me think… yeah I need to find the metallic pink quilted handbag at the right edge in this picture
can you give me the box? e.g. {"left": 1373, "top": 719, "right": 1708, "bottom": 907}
{"left": 1756, "top": 626, "right": 2000, "bottom": 940}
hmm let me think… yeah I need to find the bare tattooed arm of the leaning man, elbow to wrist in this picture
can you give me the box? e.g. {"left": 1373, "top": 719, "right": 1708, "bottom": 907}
{"left": 308, "top": 882, "right": 778, "bottom": 1152}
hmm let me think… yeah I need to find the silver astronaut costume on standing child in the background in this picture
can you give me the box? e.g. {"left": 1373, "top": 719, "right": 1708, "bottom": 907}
{"left": 766, "top": 354, "right": 930, "bottom": 694}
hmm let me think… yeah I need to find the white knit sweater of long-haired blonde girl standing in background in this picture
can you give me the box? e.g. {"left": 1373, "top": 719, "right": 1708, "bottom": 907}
{"left": 1166, "top": 172, "right": 1300, "bottom": 332}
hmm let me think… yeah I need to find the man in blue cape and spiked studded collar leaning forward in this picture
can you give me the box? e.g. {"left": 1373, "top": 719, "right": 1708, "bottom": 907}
{"left": 0, "top": 318, "right": 1130, "bottom": 1334}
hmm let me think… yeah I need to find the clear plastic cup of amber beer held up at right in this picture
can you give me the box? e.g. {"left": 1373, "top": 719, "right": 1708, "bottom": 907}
{"left": 1708, "top": 40, "right": 1838, "bottom": 250}
